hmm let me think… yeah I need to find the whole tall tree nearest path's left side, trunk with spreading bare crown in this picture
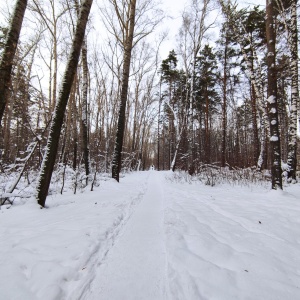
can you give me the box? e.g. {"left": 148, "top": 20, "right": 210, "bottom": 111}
{"left": 108, "top": 0, "right": 161, "bottom": 182}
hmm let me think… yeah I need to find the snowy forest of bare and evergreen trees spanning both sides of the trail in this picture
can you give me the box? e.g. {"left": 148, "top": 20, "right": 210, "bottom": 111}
{"left": 0, "top": 0, "right": 299, "bottom": 207}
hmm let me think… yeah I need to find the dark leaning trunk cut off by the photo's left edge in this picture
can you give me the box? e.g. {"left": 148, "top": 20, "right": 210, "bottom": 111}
{"left": 0, "top": 0, "right": 27, "bottom": 127}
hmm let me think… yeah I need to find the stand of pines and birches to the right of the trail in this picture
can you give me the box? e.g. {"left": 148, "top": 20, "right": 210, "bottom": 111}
{"left": 157, "top": 1, "right": 299, "bottom": 188}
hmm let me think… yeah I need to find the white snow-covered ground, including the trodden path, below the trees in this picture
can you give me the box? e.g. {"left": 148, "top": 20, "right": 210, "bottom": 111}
{"left": 0, "top": 171, "right": 300, "bottom": 300}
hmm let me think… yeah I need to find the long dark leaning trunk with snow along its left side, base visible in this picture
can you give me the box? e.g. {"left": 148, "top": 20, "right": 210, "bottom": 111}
{"left": 37, "top": 0, "right": 93, "bottom": 207}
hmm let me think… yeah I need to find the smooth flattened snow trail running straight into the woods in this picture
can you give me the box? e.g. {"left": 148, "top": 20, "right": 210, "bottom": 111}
{"left": 81, "top": 171, "right": 167, "bottom": 300}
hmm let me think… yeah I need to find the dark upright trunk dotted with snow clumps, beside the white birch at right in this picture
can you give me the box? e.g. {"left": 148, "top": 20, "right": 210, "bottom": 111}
{"left": 266, "top": 0, "right": 282, "bottom": 189}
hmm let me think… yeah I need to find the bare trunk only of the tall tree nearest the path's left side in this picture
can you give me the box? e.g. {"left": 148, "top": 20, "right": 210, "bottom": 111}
{"left": 112, "top": 0, "right": 136, "bottom": 182}
